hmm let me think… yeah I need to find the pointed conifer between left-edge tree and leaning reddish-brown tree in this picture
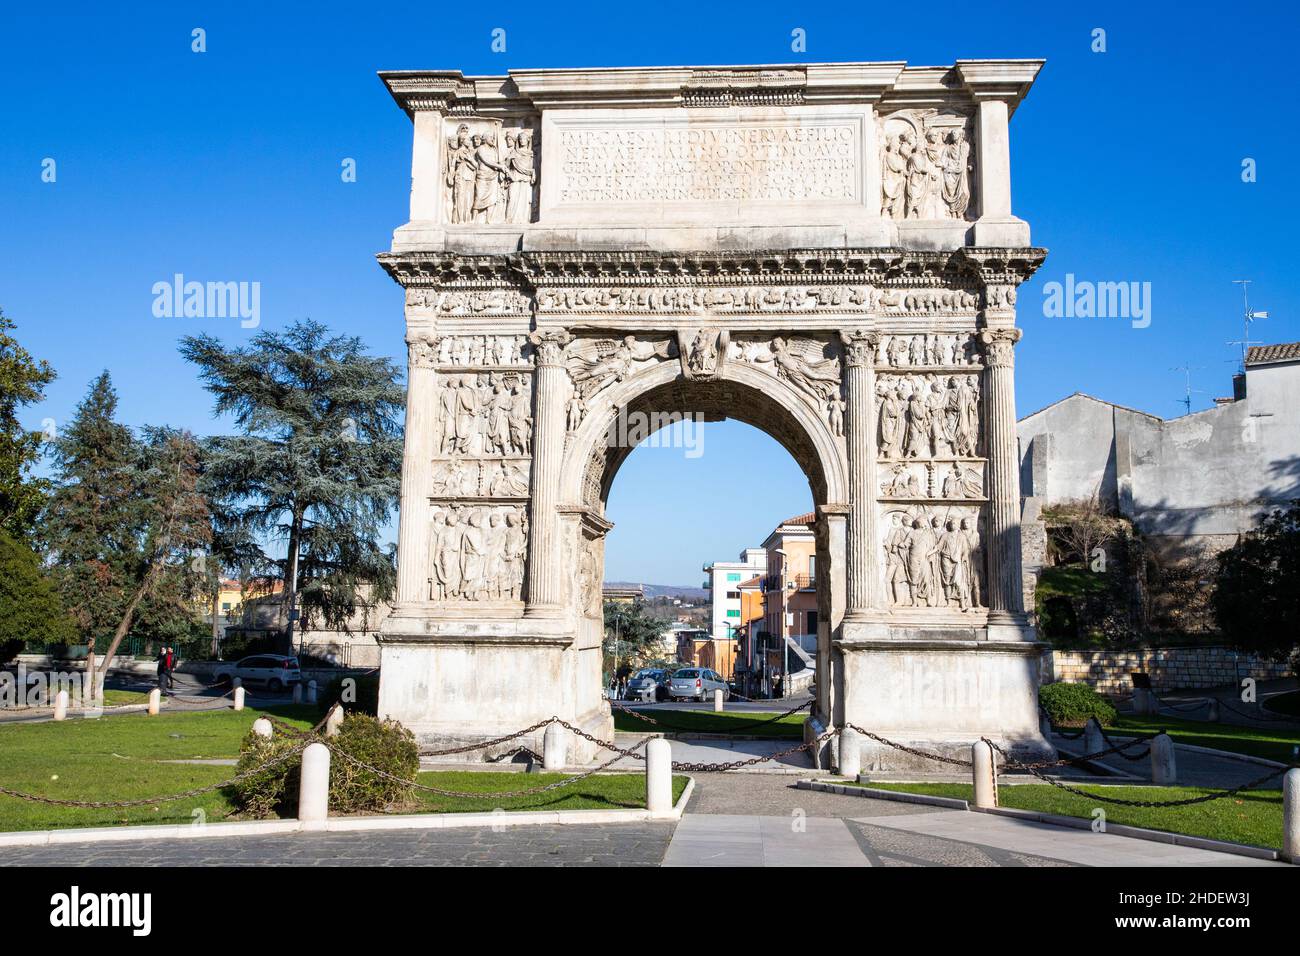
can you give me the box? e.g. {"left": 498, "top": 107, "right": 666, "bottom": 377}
{"left": 40, "top": 372, "right": 143, "bottom": 637}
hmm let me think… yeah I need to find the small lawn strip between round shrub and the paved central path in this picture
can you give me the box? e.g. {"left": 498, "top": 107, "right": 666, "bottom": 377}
{"left": 411, "top": 770, "right": 686, "bottom": 813}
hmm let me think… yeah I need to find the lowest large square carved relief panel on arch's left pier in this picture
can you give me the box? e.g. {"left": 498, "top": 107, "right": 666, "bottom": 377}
{"left": 429, "top": 503, "right": 528, "bottom": 602}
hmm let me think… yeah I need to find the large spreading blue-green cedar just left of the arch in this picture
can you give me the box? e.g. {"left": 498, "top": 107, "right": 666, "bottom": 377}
{"left": 181, "top": 321, "right": 406, "bottom": 648}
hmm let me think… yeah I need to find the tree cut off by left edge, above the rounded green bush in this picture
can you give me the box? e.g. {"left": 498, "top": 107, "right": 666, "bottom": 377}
{"left": 0, "top": 311, "right": 55, "bottom": 538}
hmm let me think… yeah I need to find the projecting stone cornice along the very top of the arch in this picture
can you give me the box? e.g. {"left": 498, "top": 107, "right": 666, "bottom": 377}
{"left": 380, "top": 60, "right": 1043, "bottom": 116}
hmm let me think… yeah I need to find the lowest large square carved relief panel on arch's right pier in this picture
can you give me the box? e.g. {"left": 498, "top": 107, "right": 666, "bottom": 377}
{"left": 883, "top": 505, "right": 984, "bottom": 611}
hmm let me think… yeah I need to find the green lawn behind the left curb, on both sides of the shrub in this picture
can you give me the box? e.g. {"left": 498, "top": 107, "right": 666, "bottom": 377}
{"left": 0, "top": 705, "right": 686, "bottom": 831}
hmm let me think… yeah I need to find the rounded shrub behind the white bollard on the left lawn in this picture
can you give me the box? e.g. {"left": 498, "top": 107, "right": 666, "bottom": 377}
{"left": 231, "top": 714, "right": 420, "bottom": 817}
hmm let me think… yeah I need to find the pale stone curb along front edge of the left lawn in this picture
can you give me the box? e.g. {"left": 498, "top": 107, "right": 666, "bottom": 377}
{"left": 0, "top": 777, "right": 696, "bottom": 848}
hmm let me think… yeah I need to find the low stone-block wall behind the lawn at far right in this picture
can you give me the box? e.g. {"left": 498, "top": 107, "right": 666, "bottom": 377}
{"left": 1041, "top": 646, "right": 1291, "bottom": 695}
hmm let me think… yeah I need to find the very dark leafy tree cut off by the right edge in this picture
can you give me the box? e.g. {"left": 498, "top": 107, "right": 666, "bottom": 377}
{"left": 1213, "top": 501, "right": 1300, "bottom": 661}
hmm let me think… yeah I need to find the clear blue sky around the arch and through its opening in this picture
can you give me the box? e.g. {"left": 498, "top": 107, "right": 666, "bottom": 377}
{"left": 0, "top": 1, "right": 1300, "bottom": 584}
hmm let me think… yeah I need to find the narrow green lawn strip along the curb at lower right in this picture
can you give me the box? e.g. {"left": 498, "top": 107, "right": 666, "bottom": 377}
{"left": 863, "top": 783, "right": 1282, "bottom": 849}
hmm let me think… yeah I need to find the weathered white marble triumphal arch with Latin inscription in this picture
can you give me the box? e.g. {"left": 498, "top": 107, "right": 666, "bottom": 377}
{"left": 380, "top": 60, "right": 1050, "bottom": 769}
